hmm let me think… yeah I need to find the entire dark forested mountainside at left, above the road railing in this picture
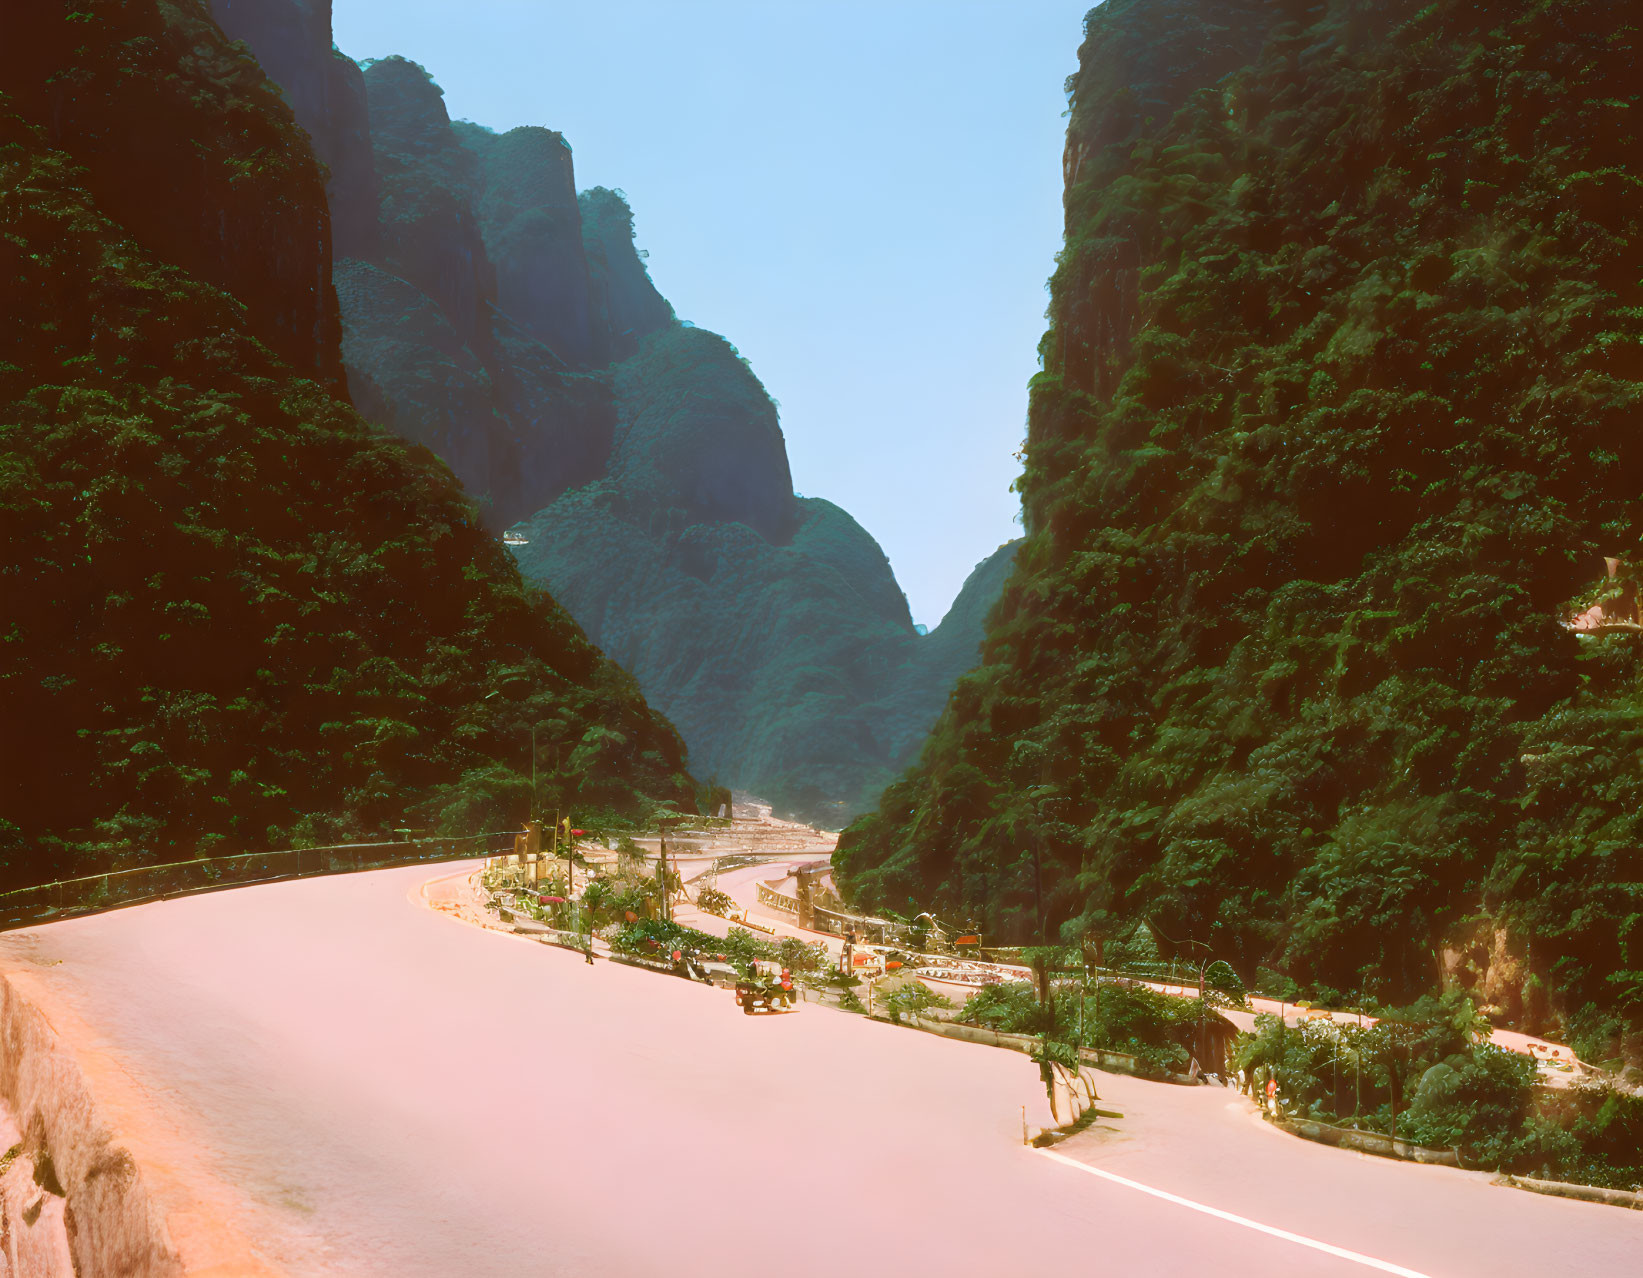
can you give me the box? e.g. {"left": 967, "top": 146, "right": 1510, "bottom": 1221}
{"left": 0, "top": 0, "right": 692, "bottom": 885}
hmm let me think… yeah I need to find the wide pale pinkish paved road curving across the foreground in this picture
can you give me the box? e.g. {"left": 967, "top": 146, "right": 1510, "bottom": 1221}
{"left": 0, "top": 867, "right": 1643, "bottom": 1278}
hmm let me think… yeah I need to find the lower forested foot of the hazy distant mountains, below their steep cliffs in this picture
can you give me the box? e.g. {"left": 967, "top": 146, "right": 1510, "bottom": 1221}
{"left": 518, "top": 466, "right": 1015, "bottom": 825}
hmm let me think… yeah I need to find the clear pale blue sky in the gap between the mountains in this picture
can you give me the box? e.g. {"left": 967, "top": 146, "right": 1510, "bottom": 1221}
{"left": 334, "top": 0, "right": 1091, "bottom": 626}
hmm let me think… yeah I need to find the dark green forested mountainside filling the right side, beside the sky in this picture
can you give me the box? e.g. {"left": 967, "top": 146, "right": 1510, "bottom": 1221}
{"left": 840, "top": 0, "right": 1643, "bottom": 1032}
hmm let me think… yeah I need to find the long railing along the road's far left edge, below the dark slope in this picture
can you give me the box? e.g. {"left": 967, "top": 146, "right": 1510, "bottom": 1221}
{"left": 0, "top": 830, "right": 522, "bottom": 931}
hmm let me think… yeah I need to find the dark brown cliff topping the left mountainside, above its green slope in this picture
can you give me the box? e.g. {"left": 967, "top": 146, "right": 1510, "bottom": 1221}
{"left": 0, "top": 0, "right": 342, "bottom": 384}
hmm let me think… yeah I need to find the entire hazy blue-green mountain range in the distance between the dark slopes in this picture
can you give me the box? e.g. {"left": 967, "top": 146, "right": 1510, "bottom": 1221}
{"left": 214, "top": 0, "right": 1009, "bottom": 823}
